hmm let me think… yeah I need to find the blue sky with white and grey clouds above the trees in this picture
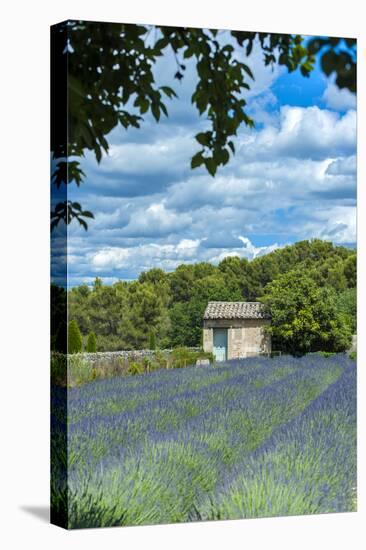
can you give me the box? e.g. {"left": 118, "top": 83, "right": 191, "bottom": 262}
{"left": 57, "top": 31, "right": 356, "bottom": 286}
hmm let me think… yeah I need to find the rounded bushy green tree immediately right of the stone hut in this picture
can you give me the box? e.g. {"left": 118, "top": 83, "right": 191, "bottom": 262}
{"left": 262, "top": 270, "right": 351, "bottom": 354}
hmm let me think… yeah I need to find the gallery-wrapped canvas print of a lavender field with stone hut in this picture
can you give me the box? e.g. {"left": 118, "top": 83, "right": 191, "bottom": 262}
{"left": 51, "top": 21, "right": 357, "bottom": 529}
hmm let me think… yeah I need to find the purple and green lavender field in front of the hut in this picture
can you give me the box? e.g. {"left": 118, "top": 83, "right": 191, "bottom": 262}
{"left": 52, "top": 354, "right": 356, "bottom": 528}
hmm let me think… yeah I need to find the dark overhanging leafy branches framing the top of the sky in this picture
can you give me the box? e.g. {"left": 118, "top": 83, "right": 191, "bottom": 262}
{"left": 51, "top": 21, "right": 356, "bottom": 229}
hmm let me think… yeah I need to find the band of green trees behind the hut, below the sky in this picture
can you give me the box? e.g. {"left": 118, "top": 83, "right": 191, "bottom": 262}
{"left": 53, "top": 240, "right": 356, "bottom": 352}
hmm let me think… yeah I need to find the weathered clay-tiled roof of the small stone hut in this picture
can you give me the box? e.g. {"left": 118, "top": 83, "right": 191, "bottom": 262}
{"left": 203, "top": 302, "right": 271, "bottom": 319}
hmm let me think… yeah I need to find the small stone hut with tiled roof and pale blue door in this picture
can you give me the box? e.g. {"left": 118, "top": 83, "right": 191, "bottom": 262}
{"left": 203, "top": 302, "right": 271, "bottom": 361}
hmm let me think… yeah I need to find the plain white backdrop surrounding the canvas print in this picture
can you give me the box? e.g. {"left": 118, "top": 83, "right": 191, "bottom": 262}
{"left": 0, "top": 0, "right": 366, "bottom": 550}
